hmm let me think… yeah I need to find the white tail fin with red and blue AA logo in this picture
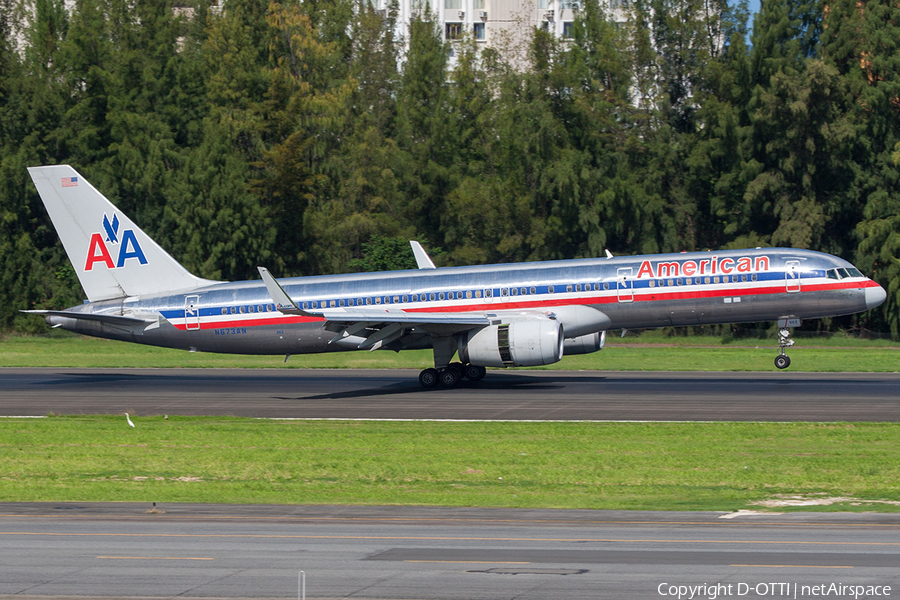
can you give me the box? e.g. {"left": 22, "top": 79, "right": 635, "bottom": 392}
{"left": 28, "top": 165, "right": 214, "bottom": 302}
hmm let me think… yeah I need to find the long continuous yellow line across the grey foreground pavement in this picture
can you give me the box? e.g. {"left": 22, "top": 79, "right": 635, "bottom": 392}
{"left": 0, "top": 531, "right": 900, "bottom": 546}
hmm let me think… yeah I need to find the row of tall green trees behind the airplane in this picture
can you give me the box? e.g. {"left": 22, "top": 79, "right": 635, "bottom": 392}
{"left": 0, "top": 0, "right": 900, "bottom": 335}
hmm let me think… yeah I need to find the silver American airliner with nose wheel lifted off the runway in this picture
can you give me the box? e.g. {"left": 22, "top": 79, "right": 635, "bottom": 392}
{"left": 23, "top": 165, "right": 886, "bottom": 388}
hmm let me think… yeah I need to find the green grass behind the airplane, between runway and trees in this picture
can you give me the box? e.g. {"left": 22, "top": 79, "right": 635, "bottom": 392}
{"left": 0, "top": 333, "right": 900, "bottom": 372}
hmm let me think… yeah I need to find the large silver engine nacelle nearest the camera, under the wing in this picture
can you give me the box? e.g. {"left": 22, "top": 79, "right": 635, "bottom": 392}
{"left": 459, "top": 319, "right": 563, "bottom": 367}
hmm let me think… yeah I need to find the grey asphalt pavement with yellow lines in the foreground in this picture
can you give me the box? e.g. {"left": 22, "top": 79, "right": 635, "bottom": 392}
{"left": 0, "top": 503, "right": 900, "bottom": 600}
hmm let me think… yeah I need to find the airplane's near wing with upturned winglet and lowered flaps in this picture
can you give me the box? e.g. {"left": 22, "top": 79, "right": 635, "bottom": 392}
{"left": 257, "top": 267, "right": 491, "bottom": 350}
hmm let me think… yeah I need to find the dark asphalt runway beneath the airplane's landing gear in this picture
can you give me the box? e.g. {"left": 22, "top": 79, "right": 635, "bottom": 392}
{"left": 0, "top": 368, "right": 900, "bottom": 422}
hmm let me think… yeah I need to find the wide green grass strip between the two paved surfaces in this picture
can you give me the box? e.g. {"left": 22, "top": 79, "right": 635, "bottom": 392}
{"left": 0, "top": 416, "right": 900, "bottom": 512}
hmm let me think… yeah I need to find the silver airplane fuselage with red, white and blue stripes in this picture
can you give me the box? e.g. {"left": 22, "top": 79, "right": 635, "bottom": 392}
{"left": 47, "top": 248, "right": 881, "bottom": 354}
